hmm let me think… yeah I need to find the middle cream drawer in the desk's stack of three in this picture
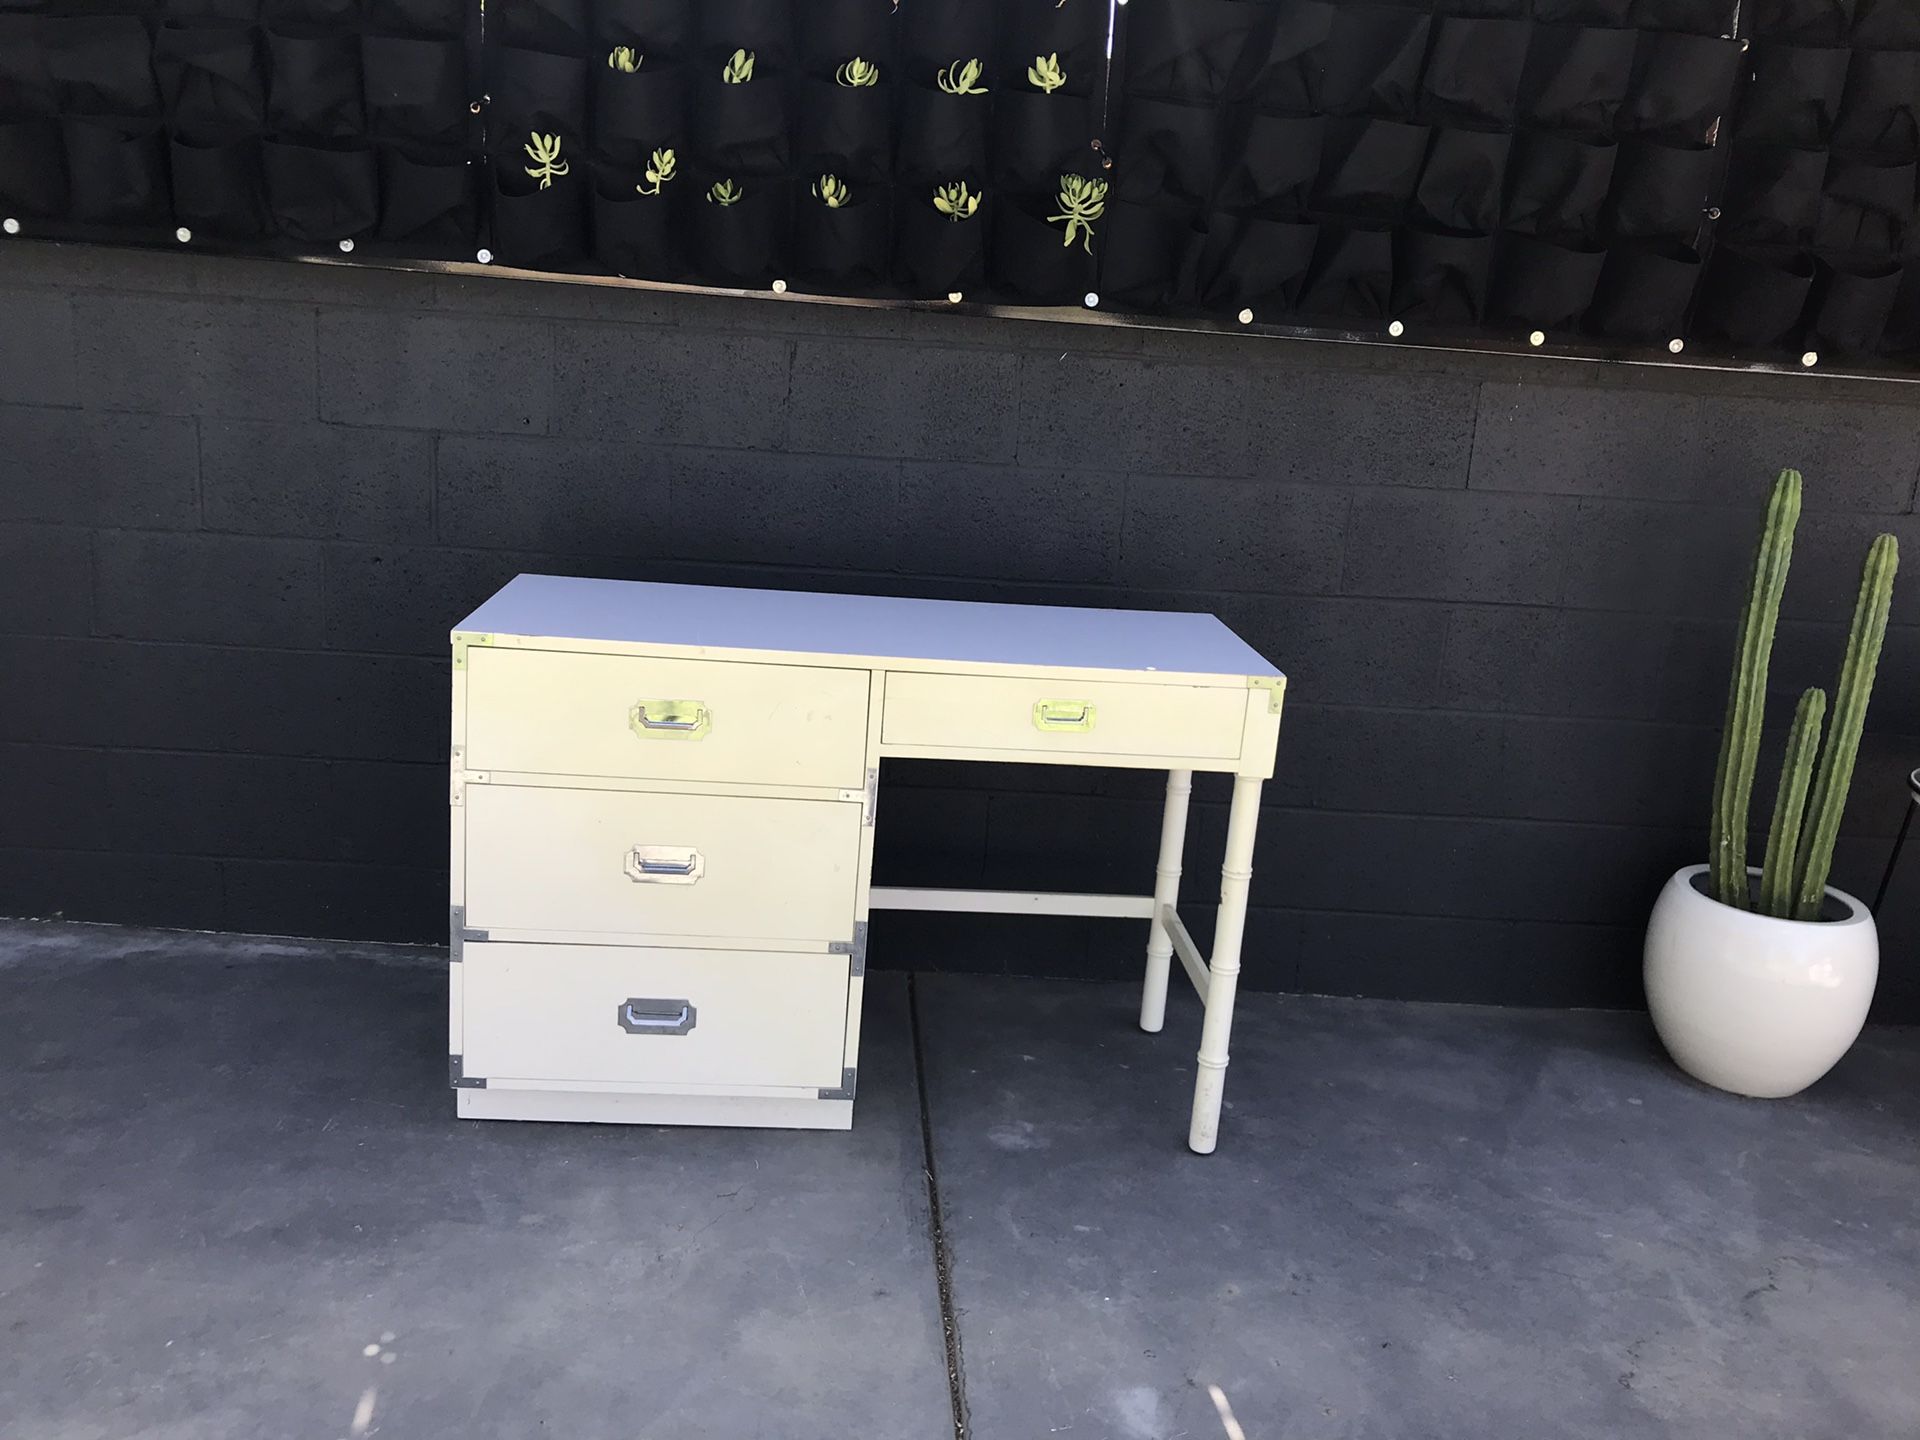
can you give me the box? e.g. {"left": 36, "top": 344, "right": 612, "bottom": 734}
{"left": 465, "top": 785, "right": 862, "bottom": 945}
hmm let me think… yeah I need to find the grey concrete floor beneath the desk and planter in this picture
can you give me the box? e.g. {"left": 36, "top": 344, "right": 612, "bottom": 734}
{"left": 0, "top": 924, "right": 1920, "bottom": 1440}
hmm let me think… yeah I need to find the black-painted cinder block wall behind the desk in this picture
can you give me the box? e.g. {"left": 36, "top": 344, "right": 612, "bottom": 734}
{"left": 0, "top": 242, "right": 1920, "bottom": 1018}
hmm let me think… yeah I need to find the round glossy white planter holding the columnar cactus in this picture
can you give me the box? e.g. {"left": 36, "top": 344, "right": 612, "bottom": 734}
{"left": 1645, "top": 866, "right": 1880, "bottom": 1100}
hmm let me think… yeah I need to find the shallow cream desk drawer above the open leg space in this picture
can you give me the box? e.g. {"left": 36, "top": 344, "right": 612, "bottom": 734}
{"left": 879, "top": 672, "right": 1248, "bottom": 760}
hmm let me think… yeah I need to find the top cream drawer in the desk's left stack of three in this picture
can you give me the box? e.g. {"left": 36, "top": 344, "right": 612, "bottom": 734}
{"left": 465, "top": 645, "right": 872, "bottom": 789}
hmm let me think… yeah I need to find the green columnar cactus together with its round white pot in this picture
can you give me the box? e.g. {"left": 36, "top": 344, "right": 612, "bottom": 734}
{"left": 1645, "top": 470, "right": 1899, "bottom": 1098}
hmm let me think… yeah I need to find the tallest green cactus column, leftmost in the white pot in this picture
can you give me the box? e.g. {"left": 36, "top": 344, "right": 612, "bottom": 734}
{"left": 1709, "top": 470, "right": 1801, "bottom": 910}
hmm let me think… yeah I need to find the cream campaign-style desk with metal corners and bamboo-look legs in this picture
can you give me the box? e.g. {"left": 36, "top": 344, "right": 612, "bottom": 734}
{"left": 447, "top": 576, "right": 1286, "bottom": 1154}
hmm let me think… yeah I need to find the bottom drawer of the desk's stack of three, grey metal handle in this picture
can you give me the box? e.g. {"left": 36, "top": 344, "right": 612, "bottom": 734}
{"left": 459, "top": 941, "right": 849, "bottom": 1089}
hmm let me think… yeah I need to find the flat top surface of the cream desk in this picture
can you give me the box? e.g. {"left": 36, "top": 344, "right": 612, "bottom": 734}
{"left": 455, "top": 574, "right": 1279, "bottom": 676}
